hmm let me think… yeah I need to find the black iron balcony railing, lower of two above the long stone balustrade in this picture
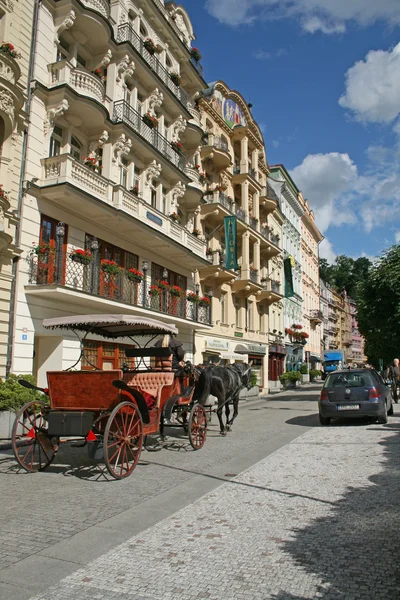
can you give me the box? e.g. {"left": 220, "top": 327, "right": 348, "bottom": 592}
{"left": 113, "top": 100, "right": 186, "bottom": 172}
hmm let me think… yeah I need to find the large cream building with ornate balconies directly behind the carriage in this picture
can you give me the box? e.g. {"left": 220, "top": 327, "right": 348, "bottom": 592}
{"left": 12, "top": 0, "right": 216, "bottom": 385}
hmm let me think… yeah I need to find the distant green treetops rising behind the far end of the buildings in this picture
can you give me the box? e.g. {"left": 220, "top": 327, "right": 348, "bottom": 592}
{"left": 319, "top": 254, "right": 372, "bottom": 300}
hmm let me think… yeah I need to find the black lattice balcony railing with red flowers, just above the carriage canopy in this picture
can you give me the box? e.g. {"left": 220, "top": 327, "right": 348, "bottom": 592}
{"left": 29, "top": 253, "right": 211, "bottom": 325}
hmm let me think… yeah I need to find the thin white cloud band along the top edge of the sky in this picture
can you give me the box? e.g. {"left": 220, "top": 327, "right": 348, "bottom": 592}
{"left": 206, "top": 0, "right": 400, "bottom": 34}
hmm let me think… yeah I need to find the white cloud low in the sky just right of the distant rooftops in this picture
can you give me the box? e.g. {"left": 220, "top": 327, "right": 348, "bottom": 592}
{"left": 291, "top": 152, "right": 358, "bottom": 231}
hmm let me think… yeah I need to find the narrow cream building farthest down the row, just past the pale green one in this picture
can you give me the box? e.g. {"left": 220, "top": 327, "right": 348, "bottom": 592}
{"left": 299, "top": 193, "right": 323, "bottom": 368}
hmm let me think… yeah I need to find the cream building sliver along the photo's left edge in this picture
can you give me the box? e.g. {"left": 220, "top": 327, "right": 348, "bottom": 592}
{"left": 0, "top": 0, "right": 34, "bottom": 377}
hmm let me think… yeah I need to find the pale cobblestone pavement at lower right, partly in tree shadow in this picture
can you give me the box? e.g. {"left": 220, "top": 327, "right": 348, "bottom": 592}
{"left": 27, "top": 409, "right": 400, "bottom": 600}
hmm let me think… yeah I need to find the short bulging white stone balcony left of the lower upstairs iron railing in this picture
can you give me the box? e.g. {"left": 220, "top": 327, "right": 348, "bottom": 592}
{"left": 48, "top": 60, "right": 105, "bottom": 104}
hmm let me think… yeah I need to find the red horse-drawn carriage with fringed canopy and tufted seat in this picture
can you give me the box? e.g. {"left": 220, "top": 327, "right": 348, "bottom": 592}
{"left": 12, "top": 315, "right": 207, "bottom": 479}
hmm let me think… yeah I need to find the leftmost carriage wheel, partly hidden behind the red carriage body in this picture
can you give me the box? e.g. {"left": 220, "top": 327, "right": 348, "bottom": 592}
{"left": 12, "top": 400, "right": 59, "bottom": 473}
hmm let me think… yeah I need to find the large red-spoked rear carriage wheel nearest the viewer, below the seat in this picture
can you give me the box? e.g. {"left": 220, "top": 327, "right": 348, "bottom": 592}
{"left": 104, "top": 402, "right": 143, "bottom": 479}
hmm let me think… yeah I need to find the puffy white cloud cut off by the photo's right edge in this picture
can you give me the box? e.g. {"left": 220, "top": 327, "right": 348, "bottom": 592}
{"left": 339, "top": 43, "right": 400, "bottom": 123}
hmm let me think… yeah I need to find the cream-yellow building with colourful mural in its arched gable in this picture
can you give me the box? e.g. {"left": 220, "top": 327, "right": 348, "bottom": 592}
{"left": 195, "top": 81, "right": 283, "bottom": 389}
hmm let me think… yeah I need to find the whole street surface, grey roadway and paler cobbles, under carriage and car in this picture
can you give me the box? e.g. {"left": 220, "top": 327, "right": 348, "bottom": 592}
{"left": 0, "top": 387, "right": 400, "bottom": 600}
